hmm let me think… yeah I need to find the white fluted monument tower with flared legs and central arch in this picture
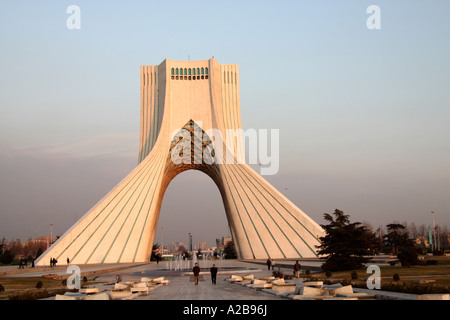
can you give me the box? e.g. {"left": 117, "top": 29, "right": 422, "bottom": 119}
{"left": 36, "top": 58, "right": 324, "bottom": 265}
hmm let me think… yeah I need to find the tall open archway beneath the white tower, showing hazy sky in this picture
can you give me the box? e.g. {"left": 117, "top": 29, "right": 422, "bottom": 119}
{"left": 153, "top": 170, "right": 231, "bottom": 252}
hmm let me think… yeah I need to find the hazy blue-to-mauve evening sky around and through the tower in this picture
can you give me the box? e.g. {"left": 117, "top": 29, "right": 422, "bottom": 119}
{"left": 0, "top": 0, "right": 450, "bottom": 245}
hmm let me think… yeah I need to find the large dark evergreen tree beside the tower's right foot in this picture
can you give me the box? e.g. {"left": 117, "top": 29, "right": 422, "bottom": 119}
{"left": 317, "top": 209, "right": 376, "bottom": 271}
